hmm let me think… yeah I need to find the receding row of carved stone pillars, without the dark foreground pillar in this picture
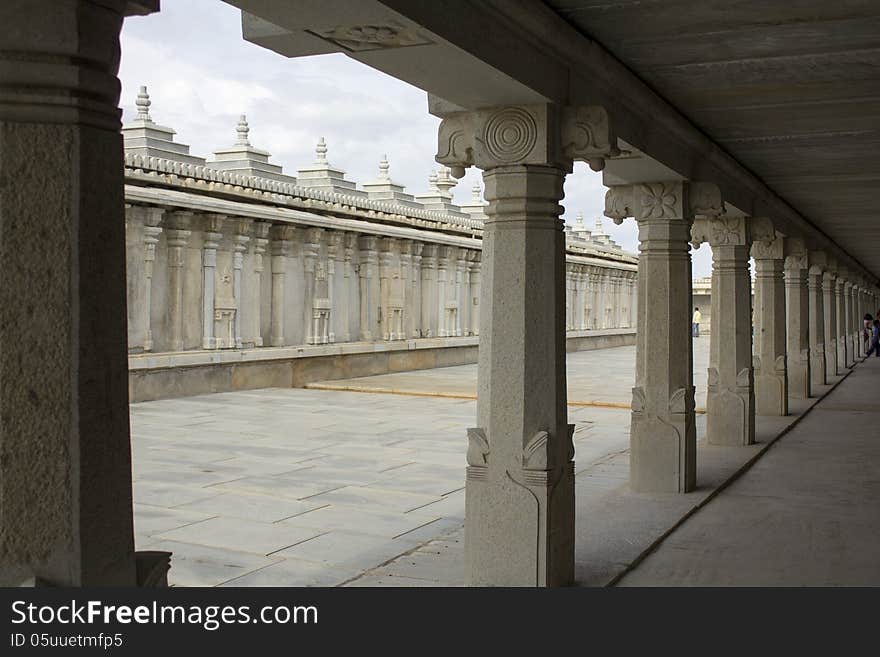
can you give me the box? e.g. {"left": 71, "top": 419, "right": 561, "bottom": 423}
{"left": 437, "top": 105, "right": 878, "bottom": 586}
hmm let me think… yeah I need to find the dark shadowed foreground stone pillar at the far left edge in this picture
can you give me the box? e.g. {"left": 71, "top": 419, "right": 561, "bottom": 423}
{"left": 0, "top": 0, "right": 158, "bottom": 587}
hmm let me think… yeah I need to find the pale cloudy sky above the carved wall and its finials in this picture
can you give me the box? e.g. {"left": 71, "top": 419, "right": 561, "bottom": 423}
{"left": 120, "top": 0, "right": 711, "bottom": 276}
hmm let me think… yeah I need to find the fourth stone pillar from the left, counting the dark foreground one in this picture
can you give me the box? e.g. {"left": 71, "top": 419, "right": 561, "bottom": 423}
{"left": 693, "top": 217, "right": 756, "bottom": 445}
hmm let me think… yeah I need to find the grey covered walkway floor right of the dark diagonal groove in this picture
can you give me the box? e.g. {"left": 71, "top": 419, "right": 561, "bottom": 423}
{"left": 619, "top": 358, "right": 880, "bottom": 586}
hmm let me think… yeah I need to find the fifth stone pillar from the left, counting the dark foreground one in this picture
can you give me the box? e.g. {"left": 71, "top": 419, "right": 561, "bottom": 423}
{"left": 752, "top": 237, "right": 788, "bottom": 415}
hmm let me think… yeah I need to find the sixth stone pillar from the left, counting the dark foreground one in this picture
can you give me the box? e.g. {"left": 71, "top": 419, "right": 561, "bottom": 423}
{"left": 785, "top": 238, "right": 810, "bottom": 399}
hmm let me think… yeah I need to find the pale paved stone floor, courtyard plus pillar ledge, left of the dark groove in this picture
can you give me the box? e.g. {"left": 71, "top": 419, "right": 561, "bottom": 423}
{"left": 131, "top": 338, "right": 860, "bottom": 586}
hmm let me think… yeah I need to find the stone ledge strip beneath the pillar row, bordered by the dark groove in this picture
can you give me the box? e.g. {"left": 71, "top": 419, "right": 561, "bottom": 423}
{"left": 344, "top": 370, "right": 850, "bottom": 586}
